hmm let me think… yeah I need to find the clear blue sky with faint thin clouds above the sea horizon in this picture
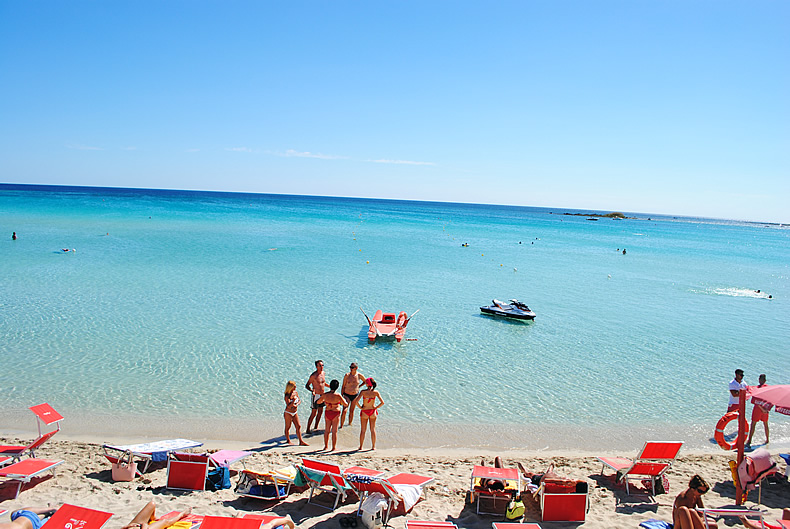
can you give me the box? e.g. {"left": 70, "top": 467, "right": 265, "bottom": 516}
{"left": 0, "top": 0, "right": 790, "bottom": 222}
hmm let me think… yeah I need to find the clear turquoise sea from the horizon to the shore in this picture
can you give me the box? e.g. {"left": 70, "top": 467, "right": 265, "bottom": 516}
{"left": 0, "top": 184, "right": 790, "bottom": 450}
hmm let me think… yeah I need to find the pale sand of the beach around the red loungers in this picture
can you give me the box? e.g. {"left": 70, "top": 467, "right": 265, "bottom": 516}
{"left": 0, "top": 434, "right": 790, "bottom": 529}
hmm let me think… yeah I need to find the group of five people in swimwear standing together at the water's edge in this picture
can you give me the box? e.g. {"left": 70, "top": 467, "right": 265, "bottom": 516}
{"left": 283, "top": 360, "right": 384, "bottom": 451}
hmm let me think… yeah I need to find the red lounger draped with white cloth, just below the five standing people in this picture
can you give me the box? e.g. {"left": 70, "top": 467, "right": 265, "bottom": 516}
{"left": 345, "top": 472, "right": 433, "bottom": 524}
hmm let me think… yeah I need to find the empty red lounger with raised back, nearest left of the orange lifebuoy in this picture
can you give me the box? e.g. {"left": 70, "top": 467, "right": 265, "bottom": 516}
{"left": 598, "top": 441, "right": 683, "bottom": 496}
